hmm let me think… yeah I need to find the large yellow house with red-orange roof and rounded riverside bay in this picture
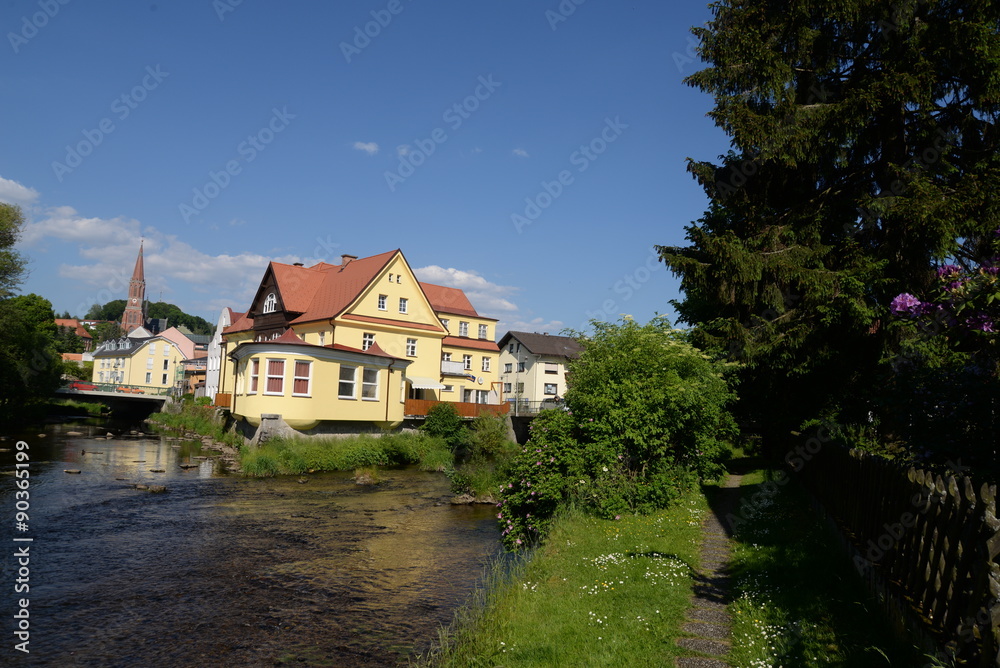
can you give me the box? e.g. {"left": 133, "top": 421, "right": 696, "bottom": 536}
{"left": 216, "top": 250, "right": 506, "bottom": 430}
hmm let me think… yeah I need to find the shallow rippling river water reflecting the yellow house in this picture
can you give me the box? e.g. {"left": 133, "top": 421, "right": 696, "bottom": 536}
{"left": 0, "top": 424, "right": 499, "bottom": 667}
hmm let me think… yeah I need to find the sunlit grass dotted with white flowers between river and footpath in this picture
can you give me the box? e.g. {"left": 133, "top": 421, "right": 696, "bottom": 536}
{"left": 415, "top": 492, "right": 707, "bottom": 668}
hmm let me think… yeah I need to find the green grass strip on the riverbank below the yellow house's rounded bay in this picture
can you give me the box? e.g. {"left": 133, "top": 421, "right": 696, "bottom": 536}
{"left": 240, "top": 433, "right": 452, "bottom": 477}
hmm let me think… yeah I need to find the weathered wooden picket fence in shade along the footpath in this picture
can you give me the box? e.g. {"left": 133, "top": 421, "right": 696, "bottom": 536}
{"left": 798, "top": 443, "right": 1000, "bottom": 668}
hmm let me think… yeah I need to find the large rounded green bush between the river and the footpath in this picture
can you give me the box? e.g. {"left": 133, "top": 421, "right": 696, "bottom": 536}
{"left": 498, "top": 318, "right": 736, "bottom": 549}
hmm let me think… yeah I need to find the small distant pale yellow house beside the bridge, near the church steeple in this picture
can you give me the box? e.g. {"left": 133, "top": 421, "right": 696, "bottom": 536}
{"left": 92, "top": 336, "right": 186, "bottom": 394}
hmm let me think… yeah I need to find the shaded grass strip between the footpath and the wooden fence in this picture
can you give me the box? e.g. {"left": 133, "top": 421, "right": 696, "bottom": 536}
{"left": 729, "top": 471, "right": 922, "bottom": 668}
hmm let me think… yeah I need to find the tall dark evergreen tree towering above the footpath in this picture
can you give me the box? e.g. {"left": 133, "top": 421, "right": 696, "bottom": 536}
{"left": 658, "top": 0, "right": 1000, "bottom": 444}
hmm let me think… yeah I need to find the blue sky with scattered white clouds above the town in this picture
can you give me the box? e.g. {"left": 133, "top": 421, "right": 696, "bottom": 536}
{"left": 0, "top": 0, "right": 728, "bottom": 336}
